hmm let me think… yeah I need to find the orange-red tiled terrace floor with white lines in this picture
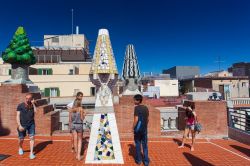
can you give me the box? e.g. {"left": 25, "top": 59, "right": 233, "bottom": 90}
{"left": 0, "top": 136, "right": 250, "bottom": 166}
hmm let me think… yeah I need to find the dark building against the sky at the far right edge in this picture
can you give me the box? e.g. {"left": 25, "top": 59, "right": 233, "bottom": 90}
{"left": 228, "top": 62, "right": 250, "bottom": 77}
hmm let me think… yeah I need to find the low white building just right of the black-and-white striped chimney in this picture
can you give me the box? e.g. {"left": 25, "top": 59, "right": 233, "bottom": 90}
{"left": 141, "top": 74, "right": 179, "bottom": 98}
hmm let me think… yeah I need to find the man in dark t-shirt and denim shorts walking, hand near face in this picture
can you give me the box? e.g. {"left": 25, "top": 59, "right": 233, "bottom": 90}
{"left": 16, "top": 93, "right": 36, "bottom": 159}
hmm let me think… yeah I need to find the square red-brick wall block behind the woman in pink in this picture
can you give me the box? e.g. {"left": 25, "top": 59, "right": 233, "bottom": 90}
{"left": 178, "top": 101, "right": 228, "bottom": 138}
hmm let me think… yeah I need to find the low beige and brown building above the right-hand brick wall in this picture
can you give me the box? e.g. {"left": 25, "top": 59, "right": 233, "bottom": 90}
{"left": 180, "top": 76, "right": 249, "bottom": 99}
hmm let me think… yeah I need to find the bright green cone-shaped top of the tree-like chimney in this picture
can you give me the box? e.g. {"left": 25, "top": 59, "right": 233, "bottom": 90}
{"left": 2, "top": 27, "right": 36, "bottom": 65}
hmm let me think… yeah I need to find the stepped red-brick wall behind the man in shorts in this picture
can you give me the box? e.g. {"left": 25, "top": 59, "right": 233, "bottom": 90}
{"left": 0, "top": 84, "right": 59, "bottom": 136}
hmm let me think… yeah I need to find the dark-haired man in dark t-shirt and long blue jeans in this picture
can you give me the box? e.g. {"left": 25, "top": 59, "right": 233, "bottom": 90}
{"left": 133, "top": 94, "right": 149, "bottom": 166}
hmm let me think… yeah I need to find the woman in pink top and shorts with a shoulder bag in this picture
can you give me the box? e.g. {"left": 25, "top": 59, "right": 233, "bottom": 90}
{"left": 178, "top": 106, "right": 197, "bottom": 151}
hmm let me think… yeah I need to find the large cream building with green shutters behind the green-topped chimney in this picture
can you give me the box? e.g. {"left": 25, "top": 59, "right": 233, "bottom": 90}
{"left": 0, "top": 34, "right": 95, "bottom": 97}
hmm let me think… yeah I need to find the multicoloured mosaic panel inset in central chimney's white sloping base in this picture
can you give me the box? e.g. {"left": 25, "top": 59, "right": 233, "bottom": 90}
{"left": 94, "top": 114, "right": 115, "bottom": 160}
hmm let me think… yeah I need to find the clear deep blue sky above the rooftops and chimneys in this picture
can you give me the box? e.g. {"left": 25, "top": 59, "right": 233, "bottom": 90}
{"left": 0, "top": 0, "right": 250, "bottom": 73}
